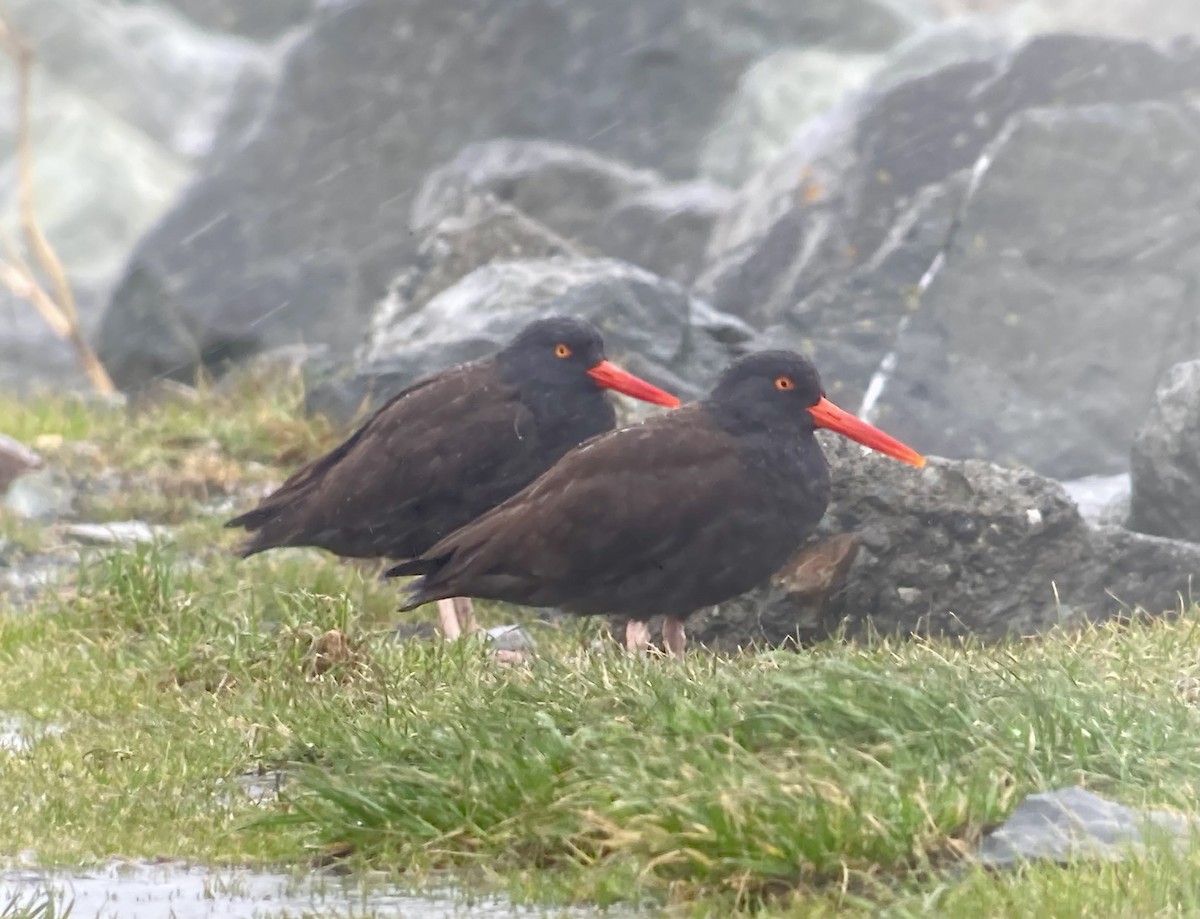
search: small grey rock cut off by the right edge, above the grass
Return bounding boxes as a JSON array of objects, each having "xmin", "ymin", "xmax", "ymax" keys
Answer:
[{"xmin": 1129, "ymin": 362, "xmax": 1200, "ymax": 542}]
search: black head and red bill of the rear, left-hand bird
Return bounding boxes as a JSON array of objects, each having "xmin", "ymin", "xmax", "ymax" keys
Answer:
[{"xmin": 497, "ymin": 316, "xmax": 679, "ymax": 407}]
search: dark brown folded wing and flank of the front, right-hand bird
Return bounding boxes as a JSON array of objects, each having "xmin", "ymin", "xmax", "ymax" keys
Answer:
[{"xmin": 397, "ymin": 404, "xmax": 801, "ymax": 615}]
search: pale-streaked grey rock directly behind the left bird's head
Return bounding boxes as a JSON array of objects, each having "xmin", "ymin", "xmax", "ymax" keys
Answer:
[{"xmin": 308, "ymin": 257, "xmax": 752, "ymax": 427}]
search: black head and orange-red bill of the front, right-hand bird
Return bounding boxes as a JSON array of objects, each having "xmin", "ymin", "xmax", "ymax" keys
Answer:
[{"xmin": 704, "ymin": 352, "xmax": 925, "ymax": 465}]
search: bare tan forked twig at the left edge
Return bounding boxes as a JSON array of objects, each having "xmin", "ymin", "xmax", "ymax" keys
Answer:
[{"xmin": 0, "ymin": 8, "xmax": 116, "ymax": 395}]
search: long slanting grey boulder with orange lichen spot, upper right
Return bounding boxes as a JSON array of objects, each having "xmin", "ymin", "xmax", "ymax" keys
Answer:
[{"xmin": 700, "ymin": 35, "xmax": 1200, "ymax": 320}]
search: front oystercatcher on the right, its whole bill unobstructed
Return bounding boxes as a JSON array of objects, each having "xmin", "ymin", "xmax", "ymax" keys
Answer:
[{"xmin": 388, "ymin": 352, "xmax": 925, "ymax": 654}]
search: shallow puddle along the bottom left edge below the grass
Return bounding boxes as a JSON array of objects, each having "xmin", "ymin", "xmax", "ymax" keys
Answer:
[{"xmin": 0, "ymin": 864, "xmax": 638, "ymax": 919}]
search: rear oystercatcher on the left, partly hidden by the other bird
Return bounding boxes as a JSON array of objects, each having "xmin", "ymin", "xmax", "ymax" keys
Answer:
[{"xmin": 226, "ymin": 317, "xmax": 679, "ymax": 639}]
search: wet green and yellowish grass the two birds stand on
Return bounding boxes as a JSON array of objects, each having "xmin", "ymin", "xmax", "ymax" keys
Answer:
[{"xmin": 0, "ymin": 379, "xmax": 1200, "ymax": 917}]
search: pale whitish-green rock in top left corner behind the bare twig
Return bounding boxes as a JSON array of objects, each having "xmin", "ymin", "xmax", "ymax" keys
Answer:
[{"xmin": 0, "ymin": 0, "xmax": 282, "ymax": 389}]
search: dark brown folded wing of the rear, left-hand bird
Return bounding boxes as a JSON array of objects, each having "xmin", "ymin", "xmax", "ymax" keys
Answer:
[{"xmin": 227, "ymin": 360, "xmax": 541, "ymax": 558}]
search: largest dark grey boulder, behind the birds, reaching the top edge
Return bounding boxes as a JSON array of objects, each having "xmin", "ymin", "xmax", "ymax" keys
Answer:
[{"xmin": 100, "ymin": 0, "xmax": 919, "ymax": 386}]
